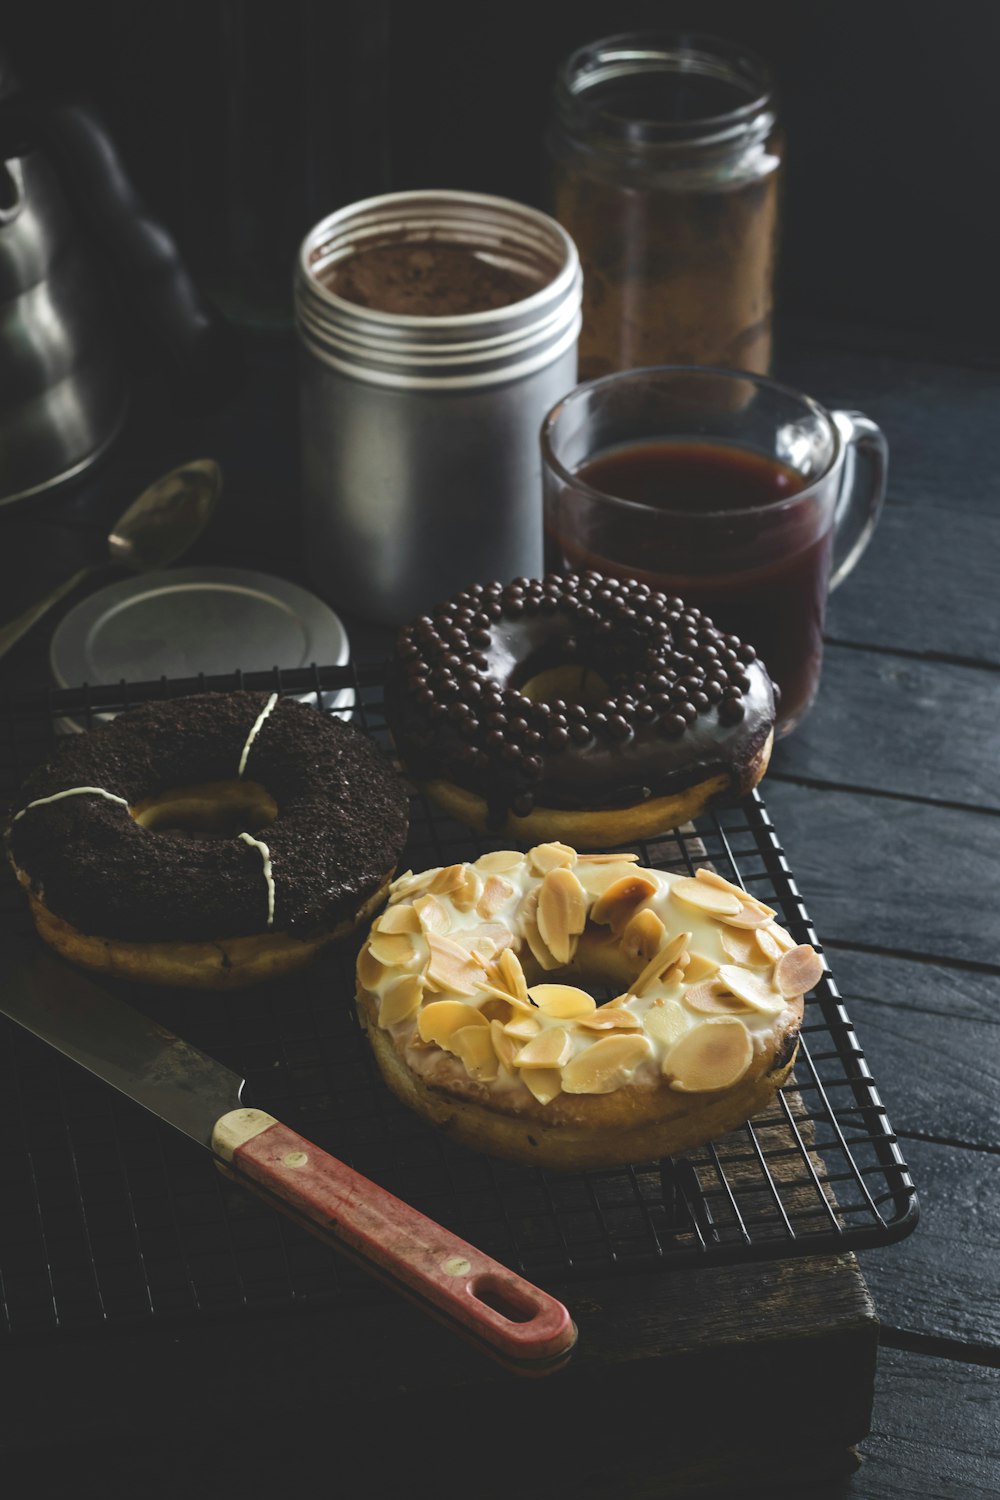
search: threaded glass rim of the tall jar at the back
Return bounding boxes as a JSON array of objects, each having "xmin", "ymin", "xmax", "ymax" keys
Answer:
[{"xmin": 556, "ymin": 32, "xmax": 774, "ymax": 146}]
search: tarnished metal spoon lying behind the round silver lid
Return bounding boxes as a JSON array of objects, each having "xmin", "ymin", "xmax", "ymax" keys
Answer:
[{"xmin": 0, "ymin": 459, "xmax": 222, "ymax": 657}]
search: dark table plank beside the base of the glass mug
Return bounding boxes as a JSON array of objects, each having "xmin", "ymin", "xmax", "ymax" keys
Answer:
[{"xmin": 768, "ymin": 645, "xmax": 1000, "ymax": 812}]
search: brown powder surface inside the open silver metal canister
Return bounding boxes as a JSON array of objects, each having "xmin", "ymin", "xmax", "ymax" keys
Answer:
[{"xmin": 319, "ymin": 240, "xmax": 544, "ymax": 318}]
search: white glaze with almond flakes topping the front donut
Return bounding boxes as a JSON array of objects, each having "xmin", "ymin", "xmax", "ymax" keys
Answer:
[{"xmin": 358, "ymin": 843, "xmax": 823, "ymax": 1106}]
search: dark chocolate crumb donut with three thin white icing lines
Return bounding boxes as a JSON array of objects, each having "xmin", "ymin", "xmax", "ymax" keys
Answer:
[{"xmin": 7, "ymin": 692, "xmax": 408, "ymax": 989}]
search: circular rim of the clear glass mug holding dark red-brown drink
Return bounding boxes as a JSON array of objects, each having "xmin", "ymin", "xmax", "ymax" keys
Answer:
[{"xmin": 540, "ymin": 365, "xmax": 844, "ymax": 524}]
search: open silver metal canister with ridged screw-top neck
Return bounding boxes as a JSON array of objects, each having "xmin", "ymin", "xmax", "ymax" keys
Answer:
[{"xmin": 295, "ymin": 191, "xmax": 582, "ymax": 626}]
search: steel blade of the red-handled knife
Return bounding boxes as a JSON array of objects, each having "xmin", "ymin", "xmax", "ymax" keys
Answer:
[{"xmin": 0, "ymin": 933, "xmax": 244, "ymax": 1148}]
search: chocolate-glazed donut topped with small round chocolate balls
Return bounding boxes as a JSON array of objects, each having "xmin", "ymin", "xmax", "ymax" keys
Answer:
[{"xmin": 387, "ymin": 572, "xmax": 774, "ymax": 848}]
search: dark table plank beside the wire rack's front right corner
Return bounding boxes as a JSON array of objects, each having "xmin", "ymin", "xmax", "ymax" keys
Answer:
[{"xmin": 859, "ymin": 1140, "xmax": 1000, "ymax": 1364}]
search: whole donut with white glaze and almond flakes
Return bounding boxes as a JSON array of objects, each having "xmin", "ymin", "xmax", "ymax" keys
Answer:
[{"xmin": 357, "ymin": 842, "xmax": 823, "ymax": 1170}]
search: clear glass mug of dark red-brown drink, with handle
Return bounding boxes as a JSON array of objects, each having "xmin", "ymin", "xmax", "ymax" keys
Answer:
[{"xmin": 541, "ymin": 366, "xmax": 888, "ymax": 735}]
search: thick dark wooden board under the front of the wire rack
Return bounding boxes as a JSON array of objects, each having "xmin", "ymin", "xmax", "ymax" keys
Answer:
[{"xmin": 0, "ymin": 1256, "xmax": 877, "ymax": 1500}]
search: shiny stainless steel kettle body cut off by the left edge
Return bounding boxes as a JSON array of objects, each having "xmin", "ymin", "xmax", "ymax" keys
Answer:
[{"xmin": 0, "ymin": 152, "xmax": 127, "ymax": 504}]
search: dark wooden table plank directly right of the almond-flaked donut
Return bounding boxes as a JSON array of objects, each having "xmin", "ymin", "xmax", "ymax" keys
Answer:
[{"xmin": 831, "ymin": 951, "xmax": 1000, "ymax": 1151}]
